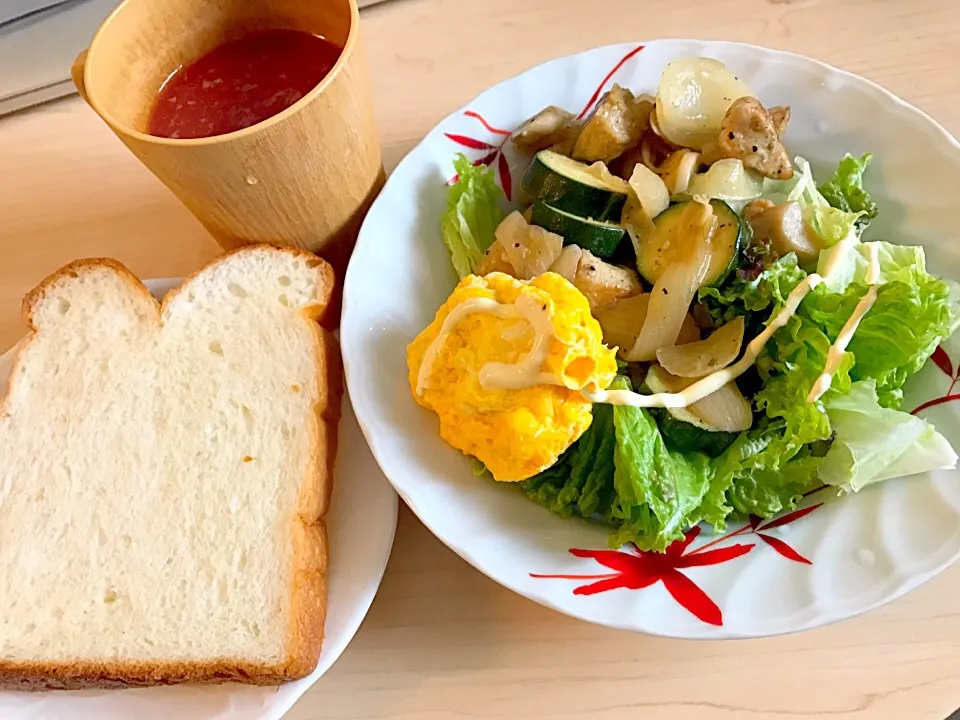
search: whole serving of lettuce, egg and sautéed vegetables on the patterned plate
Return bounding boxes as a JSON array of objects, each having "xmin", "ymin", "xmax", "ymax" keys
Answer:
[{"xmin": 408, "ymin": 58, "xmax": 960, "ymax": 551}]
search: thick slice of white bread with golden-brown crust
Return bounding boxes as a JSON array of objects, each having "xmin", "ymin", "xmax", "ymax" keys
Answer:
[{"xmin": 0, "ymin": 246, "xmax": 341, "ymax": 689}]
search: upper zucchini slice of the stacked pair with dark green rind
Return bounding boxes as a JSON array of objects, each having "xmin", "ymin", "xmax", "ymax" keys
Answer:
[{"xmin": 523, "ymin": 150, "xmax": 630, "ymax": 221}]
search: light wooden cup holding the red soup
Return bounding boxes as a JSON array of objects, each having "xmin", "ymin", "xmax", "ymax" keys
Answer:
[{"xmin": 73, "ymin": 0, "xmax": 384, "ymax": 279}]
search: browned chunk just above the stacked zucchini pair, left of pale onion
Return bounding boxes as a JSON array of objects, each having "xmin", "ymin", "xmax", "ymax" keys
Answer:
[{"xmin": 572, "ymin": 84, "xmax": 653, "ymax": 163}]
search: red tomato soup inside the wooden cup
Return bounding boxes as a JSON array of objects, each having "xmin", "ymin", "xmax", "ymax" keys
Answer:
[{"xmin": 147, "ymin": 30, "xmax": 341, "ymax": 138}]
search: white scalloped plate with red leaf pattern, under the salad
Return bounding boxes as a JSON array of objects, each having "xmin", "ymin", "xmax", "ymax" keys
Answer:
[{"xmin": 342, "ymin": 40, "xmax": 960, "ymax": 638}]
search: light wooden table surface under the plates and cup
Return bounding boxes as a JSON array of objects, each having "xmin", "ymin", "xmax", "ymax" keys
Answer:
[{"xmin": 0, "ymin": 0, "xmax": 960, "ymax": 720}]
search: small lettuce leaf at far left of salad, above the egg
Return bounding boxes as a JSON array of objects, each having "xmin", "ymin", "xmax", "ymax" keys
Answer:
[{"xmin": 440, "ymin": 154, "xmax": 503, "ymax": 277}]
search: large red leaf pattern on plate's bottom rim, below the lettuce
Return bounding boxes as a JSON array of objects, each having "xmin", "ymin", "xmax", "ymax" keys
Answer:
[{"xmin": 530, "ymin": 496, "xmax": 824, "ymax": 626}]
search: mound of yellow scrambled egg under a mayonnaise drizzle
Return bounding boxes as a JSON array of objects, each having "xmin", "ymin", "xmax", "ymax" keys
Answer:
[{"xmin": 407, "ymin": 272, "xmax": 617, "ymax": 481}]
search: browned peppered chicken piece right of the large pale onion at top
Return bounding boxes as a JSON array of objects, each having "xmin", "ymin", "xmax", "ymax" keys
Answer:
[{"xmin": 717, "ymin": 97, "xmax": 793, "ymax": 180}]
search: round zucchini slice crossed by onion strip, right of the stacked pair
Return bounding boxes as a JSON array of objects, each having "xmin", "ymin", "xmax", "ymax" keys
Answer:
[{"xmin": 637, "ymin": 200, "xmax": 748, "ymax": 287}]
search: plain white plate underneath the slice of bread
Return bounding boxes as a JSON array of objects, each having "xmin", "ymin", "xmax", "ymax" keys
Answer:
[{"xmin": 0, "ymin": 279, "xmax": 398, "ymax": 720}]
